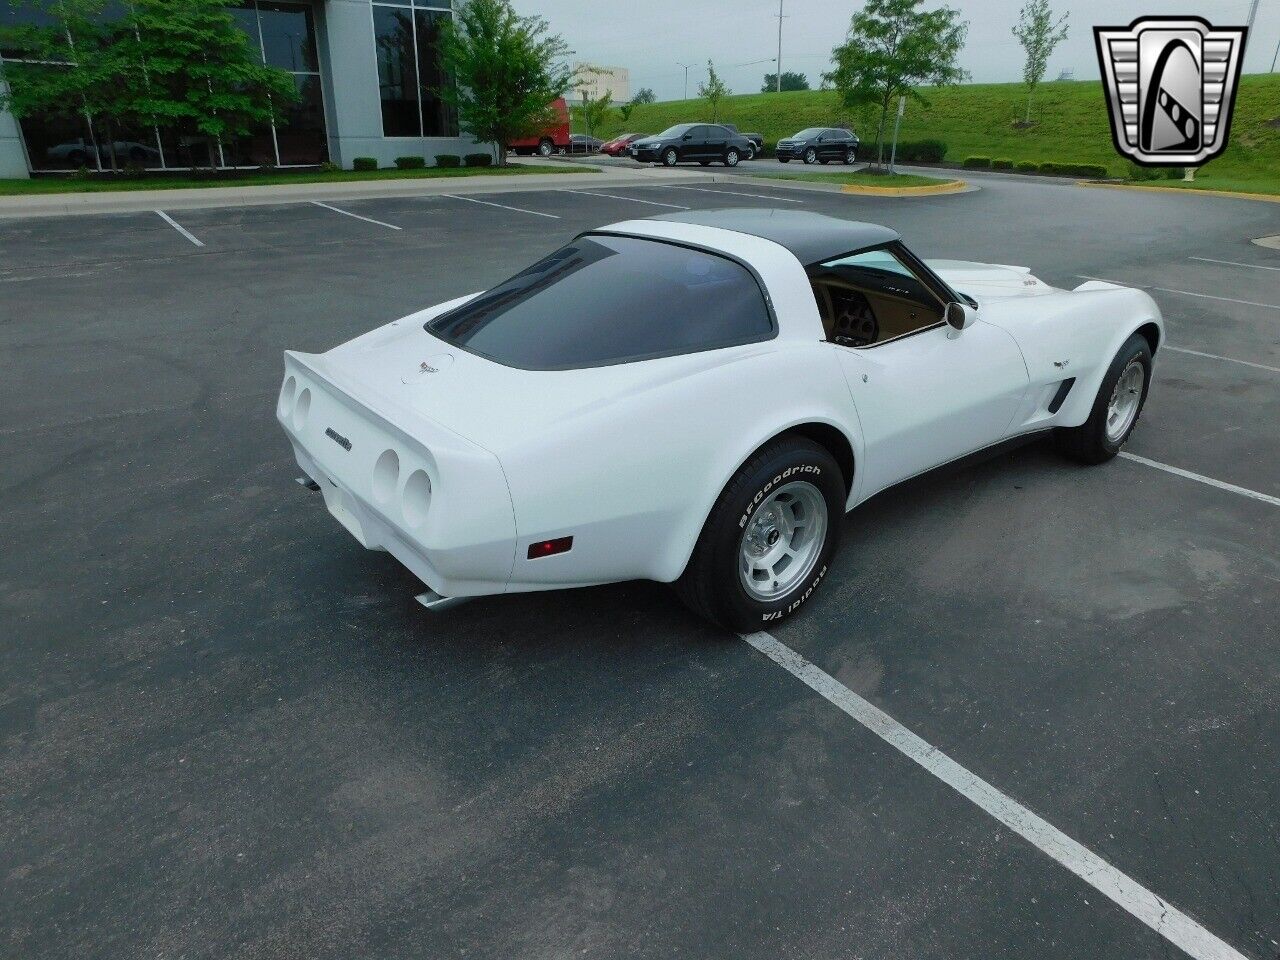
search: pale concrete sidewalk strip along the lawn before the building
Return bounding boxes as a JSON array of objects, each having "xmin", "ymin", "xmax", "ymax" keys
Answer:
[{"xmin": 0, "ymin": 168, "xmax": 723, "ymax": 219}]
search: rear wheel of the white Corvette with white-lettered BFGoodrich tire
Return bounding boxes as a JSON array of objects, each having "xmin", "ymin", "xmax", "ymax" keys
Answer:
[{"xmin": 676, "ymin": 436, "xmax": 845, "ymax": 632}]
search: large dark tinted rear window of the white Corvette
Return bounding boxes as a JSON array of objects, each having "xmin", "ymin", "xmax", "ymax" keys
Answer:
[{"xmin": 426, "ymin": 234, "xmax": 773, "ymax": 370}]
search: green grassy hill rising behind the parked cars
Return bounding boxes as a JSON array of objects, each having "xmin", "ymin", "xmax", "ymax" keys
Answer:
[{"xmin": 586, "ymin": 73, "xmax": 1280, "ymax": 192}]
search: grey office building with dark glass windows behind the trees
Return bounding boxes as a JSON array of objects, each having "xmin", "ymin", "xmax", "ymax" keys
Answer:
[{"xmin": 0, "ymin": 0, "xmax": 471, "ymax": 177}]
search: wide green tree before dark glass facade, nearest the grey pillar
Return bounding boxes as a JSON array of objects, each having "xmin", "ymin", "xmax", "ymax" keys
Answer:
[{"xmin": 119, "ymin": 0, "xmax": 298, "ymax": 166}]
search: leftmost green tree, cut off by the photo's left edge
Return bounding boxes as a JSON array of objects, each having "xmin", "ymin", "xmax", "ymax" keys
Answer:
[{"xmin": 0, "ymin": 0, "xmax": 136, "ymax": 170}]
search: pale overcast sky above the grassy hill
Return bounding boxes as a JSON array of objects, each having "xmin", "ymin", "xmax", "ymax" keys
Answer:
[{"xmin": 513, "ymin": 0, "xmax": 1280, "ymax": 100}]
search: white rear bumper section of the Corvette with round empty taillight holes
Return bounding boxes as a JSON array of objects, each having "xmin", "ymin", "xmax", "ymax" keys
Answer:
[{"xmin": 276, "ymin": 351, "xmax": 516, "ymax": 596}]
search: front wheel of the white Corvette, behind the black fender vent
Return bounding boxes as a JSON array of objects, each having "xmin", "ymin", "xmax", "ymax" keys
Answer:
[{"xmin": 1053, "ymin": 334, "xmax": 1151, "ymax": 463}]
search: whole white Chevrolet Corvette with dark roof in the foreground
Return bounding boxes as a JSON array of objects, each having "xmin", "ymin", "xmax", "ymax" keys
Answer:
[{"xmin": 276, "ymin": 209, "xmax": 1164, "ymax": 630}]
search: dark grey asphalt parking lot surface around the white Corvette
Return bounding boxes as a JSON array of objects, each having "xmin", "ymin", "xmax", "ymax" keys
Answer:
[{"xmin": 0, "ymin": 172, "xmax": 1280, "ymax": 960}]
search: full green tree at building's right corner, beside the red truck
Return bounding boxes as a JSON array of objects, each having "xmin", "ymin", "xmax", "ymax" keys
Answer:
[{"xmin": 440, "ymin": 0, "xmax": 573, "ymax": 166}]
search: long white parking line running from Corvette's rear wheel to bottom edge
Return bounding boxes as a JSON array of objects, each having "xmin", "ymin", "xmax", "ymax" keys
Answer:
[{"xmin": 742, "ymin": 634, "xmax": 1245, "ymax": 960}]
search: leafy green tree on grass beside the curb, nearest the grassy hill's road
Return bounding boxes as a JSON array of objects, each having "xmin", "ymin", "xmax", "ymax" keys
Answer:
[{"xmin": 823, "ymin": 0, "xmax": 969, "ymax": 164}]
